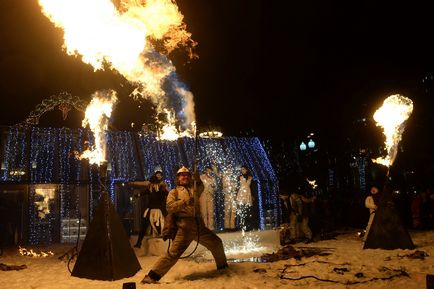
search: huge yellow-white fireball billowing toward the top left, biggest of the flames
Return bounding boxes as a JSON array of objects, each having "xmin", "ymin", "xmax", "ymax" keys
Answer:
[{"xmin": 39, "ymin": 0, "xmax": 197, "ymax": 138}]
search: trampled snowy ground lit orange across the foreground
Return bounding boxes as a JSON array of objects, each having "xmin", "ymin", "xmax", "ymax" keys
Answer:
[{"xmin": 0, "ymin": 230, "xmax": 434, "ymax": 289}]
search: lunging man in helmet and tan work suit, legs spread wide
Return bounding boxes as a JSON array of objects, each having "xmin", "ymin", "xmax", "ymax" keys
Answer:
[{"xmin": 142, "ymin": 167, "xmax": 228, "ymax": 284}]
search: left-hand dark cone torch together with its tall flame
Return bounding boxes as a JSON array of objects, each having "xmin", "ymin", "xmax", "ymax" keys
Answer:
[{"xmin": 71, "ymin": 91, "xmax": 141, "ymax": 280}]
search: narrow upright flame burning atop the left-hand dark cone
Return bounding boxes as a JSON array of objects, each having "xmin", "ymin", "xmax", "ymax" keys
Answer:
[{"xmin": 80, "ymin": 90, "xmax": 117, "ymax": 166}]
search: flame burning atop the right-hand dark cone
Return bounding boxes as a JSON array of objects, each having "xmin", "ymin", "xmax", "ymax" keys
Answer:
[{"xmin": 374, "ymin": 94, "xmax": 413, "ymax": 167}]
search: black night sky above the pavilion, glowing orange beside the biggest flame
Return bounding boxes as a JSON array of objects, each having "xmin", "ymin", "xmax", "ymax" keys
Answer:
[{"xmin": 0, "ymin": 0, "xmax": 434, "ymax": 144}]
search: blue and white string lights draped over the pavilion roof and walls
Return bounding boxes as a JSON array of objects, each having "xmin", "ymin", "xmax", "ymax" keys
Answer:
[{"xmin": 0, "ymin": 126, "xmax": 279, "ymax": 244}]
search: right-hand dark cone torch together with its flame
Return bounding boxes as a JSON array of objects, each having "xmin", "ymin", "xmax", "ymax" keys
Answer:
[{"xmin": 363, "ymin": 94, "xmax": 414, "ymax": 249}]
